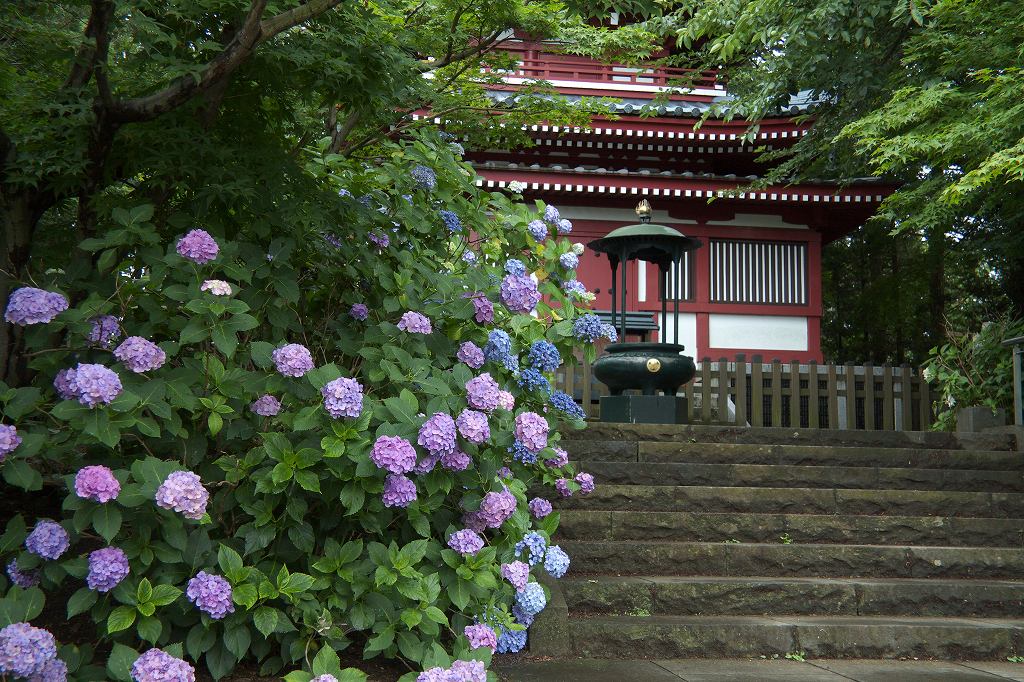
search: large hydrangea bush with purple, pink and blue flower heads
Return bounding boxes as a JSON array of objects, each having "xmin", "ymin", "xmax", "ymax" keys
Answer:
[{"xmin": 0, "ymin": 130, "xmax": 600, "ymax": 682}]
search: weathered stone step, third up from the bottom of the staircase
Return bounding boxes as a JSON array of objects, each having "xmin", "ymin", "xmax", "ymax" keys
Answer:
[{"xmin": 560, "ymin": 540, "xmax": 1024, "ymax": 579}]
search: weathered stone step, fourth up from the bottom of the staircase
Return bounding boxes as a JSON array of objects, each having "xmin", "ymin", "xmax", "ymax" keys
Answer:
[{"xmin": 558, "ymin": 509, "xmax": 1024, "ymax": 547}]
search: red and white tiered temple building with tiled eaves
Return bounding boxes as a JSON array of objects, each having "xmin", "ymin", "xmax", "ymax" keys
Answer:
[{"xmin": 467, "ymin": 33, "xmax": 888, "ymax": 361}]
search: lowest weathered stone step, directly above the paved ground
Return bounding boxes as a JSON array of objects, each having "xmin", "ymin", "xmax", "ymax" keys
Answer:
[{"xmin": 530, "ymin": 615, "xmax": 1024, "ymax": 659}]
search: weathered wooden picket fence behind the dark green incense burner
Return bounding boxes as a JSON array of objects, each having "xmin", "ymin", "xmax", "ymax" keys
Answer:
[{"xmin": 555, "ymin": 355, "xmax": 933, "ymax": 431}]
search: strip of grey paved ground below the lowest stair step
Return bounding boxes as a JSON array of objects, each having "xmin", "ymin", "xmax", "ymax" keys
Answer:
[{"xmin": 498, "ymin": 658, "xmax": 1024, "ymax": 682}]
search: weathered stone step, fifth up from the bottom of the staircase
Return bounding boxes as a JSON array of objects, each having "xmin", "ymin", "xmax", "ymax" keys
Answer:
[{"xmin": 559, "ymin": 485, "xmax": 1024, "ymax": 518}]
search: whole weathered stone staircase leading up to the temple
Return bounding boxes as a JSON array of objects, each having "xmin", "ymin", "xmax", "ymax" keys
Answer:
[{"xmin": 529, "ymin": 424, "xmax": 1024, "ymax": 659}]
